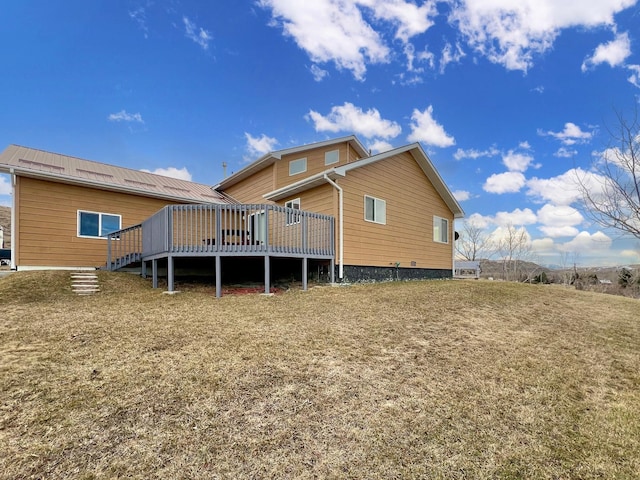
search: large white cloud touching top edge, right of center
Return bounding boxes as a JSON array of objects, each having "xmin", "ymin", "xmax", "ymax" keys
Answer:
[{"xmin": 450, "ymin": 0, "xmax": 637, "ymax": 71}]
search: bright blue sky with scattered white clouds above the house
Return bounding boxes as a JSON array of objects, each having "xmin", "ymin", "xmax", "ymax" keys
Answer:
[{"xmin": 0, "ymin": 0, "xmax": 640, "ymax": 265}]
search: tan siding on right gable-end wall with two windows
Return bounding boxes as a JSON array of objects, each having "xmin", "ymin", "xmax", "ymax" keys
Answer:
[{"xmin": 339, "ymin": 153, "xmax": 453, "ymax": 269}]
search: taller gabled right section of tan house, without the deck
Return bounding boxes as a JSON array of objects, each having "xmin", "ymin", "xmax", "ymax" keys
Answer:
[{"xmin": 216, "ymin": 136, "xmax": 464, "ymax": 281}]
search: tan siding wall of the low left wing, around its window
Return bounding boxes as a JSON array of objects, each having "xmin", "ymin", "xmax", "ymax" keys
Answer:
[{"xmin": 16, "ymin": 177, "xmax": 182, "ymax": 267}]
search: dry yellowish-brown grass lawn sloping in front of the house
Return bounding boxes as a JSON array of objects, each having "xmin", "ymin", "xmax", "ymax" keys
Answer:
[{"xmin": 0, "ymin": 272, "xmax": 640, "ymax": 479}]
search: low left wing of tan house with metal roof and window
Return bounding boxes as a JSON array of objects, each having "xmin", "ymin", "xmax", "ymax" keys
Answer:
[{"xmin": 0, "ymin": 145, "xmax": 226, "ymax": 270}]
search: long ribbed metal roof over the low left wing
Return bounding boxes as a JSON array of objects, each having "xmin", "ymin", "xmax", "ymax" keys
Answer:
[{"xmin": 0, "ymin": 145, "xmax": 230, "ymax": 203}]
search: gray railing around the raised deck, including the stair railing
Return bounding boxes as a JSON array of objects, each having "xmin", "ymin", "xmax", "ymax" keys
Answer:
[{"xmin": 107, "ymin": 204, "xmax": 335, "ymax": 269}]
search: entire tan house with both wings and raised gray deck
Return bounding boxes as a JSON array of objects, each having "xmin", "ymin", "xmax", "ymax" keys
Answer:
[{"xmin": 0, "ymin": 136, "xmax": 463, "ymax": 294}]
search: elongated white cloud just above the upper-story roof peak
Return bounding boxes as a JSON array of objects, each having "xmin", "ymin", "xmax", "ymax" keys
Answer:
[{"xmin": 307, "ymin": 102, "xmax": 402, "ymax": 139}]
